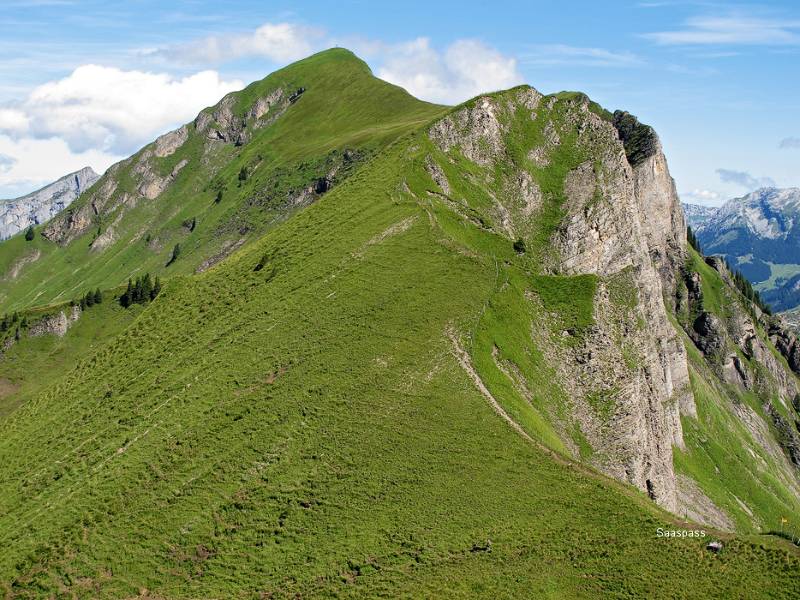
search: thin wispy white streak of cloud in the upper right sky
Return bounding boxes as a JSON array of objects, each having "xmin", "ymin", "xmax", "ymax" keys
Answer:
[{"xmin": 642, "ymin": 15, "xmax": 800, "ymax": 46}]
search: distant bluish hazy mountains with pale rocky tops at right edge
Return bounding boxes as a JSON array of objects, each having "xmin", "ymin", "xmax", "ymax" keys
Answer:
[{"xmin": 684, "ymin": 188, "xmax": 800, "ymax": 311}]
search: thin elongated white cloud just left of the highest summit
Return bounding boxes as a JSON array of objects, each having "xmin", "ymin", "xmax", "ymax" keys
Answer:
[{"xmin": 145, "ymin": 23, "xmax": 324, "ymax": 64}]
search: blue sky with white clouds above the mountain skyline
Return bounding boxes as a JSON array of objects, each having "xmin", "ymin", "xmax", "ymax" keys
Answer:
[{"xmin": 0, "ymin": 0, "xmax": 800, "ymax": 204}]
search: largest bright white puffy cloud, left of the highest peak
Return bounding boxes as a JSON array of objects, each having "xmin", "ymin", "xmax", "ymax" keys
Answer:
[{"xmin": 0, "ymin": 65, "xmax": 243, "ymax": 154}]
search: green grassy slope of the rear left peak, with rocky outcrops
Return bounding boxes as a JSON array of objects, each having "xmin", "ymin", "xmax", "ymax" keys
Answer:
[{"xmin": 0, "ymin": 49, "xmax": 442, "ymax": 311}]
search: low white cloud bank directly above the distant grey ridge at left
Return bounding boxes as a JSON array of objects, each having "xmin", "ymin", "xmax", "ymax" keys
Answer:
[{"xmin": 0, "ymin": 135, "xmax": 123, "ymax": 198}]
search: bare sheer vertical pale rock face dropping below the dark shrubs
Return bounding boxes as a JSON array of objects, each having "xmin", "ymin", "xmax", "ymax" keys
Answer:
[{"xmin": 555, "ymin": 103, "xmax": 695, "ymax": 510}]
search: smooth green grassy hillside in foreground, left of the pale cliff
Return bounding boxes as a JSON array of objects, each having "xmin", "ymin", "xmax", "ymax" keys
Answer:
[{"xmin": 0, "ymin": 51, "xmax": 800, "ymax": 598}]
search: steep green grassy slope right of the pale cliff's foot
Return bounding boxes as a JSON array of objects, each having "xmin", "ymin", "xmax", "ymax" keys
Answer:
[{"xmin": 675, "ymin": 248, "xmax": 800, "ymax": 530}]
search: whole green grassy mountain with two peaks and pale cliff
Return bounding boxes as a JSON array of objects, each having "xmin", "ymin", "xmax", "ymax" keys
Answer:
[{"xmin": 0, "ymin": 49, "xmax": 800, "ymax": 598}]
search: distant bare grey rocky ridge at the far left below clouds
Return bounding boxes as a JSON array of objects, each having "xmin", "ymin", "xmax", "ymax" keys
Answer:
[{"xmin": 0, "ymin": 167, "xmax": 99, "ymax": 239}]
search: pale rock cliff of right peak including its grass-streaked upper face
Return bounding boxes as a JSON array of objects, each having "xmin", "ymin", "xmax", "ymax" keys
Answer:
[{"xmin": 428, "ymin": 88, "xmax": 694, "ymax": 510}]
